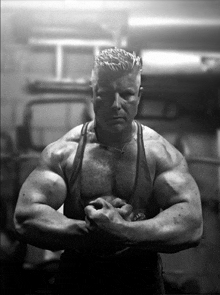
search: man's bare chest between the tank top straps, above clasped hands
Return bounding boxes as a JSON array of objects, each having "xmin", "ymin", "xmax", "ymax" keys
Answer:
[{"xmin": 81, "ymin": 144, "xmax": 137, "ymax": 206}]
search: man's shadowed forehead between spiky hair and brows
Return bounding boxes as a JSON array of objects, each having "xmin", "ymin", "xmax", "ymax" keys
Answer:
[{"xmin": 97, "ymin": 72, "xmax": 141, "ymax": 90}]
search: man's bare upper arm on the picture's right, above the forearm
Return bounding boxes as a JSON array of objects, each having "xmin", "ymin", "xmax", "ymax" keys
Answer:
[{"xmin": 150, "ymin": 138, "xmax": 200, "ymax": 210}]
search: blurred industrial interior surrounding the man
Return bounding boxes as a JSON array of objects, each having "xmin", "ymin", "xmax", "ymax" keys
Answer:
[{"xmin": 0, "ymin": 0, "xmax": 220, "ymax": 295}]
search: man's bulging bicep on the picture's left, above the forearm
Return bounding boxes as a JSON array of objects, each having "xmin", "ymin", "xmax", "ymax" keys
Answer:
[{"xmin": 18, "ymin": 167, "xmax": 66, "ymax": 210}]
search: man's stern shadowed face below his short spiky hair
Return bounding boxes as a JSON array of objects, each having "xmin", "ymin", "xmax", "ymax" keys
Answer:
[{"xmin": 93, "ymin": 72, "xmax": 141, "ymax": 132}]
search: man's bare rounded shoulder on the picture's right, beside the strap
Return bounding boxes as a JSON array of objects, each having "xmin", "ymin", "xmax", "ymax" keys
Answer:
[{"xmin": 142, "ymin": 125, "xmax": 188, "ymax": 173}]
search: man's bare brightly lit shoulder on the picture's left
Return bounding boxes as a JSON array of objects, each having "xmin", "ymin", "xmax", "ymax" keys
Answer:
[{"xmin": 39, "ymin": 125, "xmax": 83, "ymax": 169}]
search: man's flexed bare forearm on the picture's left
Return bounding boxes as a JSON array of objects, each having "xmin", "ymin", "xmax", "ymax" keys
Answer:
[{"xmin": 14, "ymin": 204, "xmax": 88, "ymax": 250}]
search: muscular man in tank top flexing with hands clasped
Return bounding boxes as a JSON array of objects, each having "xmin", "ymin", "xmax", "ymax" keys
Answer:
[{"xmin": 15, "ymin": 48, "xmax": 202, "ymax": 295}]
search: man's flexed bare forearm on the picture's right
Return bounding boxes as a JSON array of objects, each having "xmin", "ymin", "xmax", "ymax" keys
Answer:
[{"xmin": 120, "ymin": 204, "xmax": 202, "ymax": 253}]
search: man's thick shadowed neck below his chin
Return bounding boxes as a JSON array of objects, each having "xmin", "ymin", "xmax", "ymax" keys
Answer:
[{"xmin": 94, "ymin": 121, "xmax": 136, "ymax": 148}]
